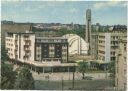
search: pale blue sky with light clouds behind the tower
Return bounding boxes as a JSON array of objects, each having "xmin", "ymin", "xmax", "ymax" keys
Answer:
[{"xmin": 1, "ymin": 0, "xmax": 127, "ymax": 25}]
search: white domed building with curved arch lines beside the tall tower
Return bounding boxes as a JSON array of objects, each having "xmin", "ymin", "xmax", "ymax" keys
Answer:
[{"xmin": 63, "ymin": 34, "xmax": 88, "ymax": 55}]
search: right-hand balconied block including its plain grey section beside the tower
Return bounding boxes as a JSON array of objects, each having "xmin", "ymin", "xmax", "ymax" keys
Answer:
[{"xmin": 92, "ymin": 25, "xmax": 127, "ymax": 62}]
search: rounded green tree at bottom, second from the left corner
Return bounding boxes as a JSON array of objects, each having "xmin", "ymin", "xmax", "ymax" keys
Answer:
[{"xmin": 15, "ymin": 67, "xmax": 35, "ymax": 90}]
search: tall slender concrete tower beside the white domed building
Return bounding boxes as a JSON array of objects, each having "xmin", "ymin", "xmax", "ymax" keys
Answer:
[{"xmin": 85, "ymin": 9, "xmax": 91, "ymax": 55}]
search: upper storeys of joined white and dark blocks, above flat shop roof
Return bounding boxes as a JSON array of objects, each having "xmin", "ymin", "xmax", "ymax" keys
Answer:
[{"xmin": 6, "ymin": 32, "xmax": 68, "ymax": 63}]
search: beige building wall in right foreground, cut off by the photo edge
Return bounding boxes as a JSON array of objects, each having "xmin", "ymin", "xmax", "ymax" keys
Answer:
[{"xmin": 115, "ymin": 38, "xmax": 127, "ymax": 91}]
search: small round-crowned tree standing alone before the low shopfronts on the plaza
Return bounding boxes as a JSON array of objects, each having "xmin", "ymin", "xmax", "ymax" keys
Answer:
[{"xmin": 78, "ymin": 61, "xmax": 89, "ymax": 79}]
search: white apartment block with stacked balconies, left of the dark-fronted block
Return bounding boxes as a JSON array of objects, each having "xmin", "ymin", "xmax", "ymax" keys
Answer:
[{"xmin": 6, "ymin": 32, "xmax": 35, "ymax": 61}]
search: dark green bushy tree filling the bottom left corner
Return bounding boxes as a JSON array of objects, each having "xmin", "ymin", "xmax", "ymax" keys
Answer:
[{"xmin": 1, "ymin": 63, "xmax": 17, "ymax": 89}]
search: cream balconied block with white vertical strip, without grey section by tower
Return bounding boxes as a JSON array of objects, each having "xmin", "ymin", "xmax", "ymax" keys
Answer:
[{"xmin": 97, "ymin": 26, "xmax": 127, "ymax": 62}]
